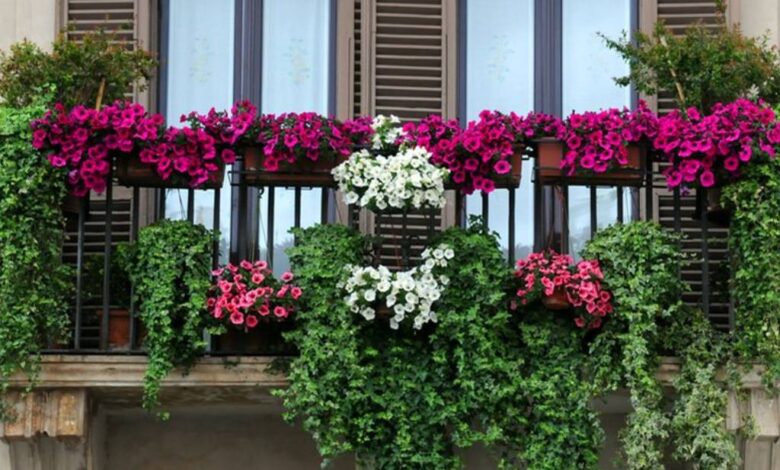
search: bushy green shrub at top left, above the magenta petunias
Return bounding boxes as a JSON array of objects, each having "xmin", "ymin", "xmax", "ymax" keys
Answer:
[{"xmin": 0, "ymin": 30, "xmax": 157, "ymax": 107}]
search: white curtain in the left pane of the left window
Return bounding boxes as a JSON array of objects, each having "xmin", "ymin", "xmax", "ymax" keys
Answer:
[{"xmin": 163, "ymin": 0, "xmax": 235, "ymax": 262}]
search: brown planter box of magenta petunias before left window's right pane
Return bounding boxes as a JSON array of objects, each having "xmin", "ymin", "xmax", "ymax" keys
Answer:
[{"xmin": 243, "ymin": 147, "xmax": 345, "ymax": 188}]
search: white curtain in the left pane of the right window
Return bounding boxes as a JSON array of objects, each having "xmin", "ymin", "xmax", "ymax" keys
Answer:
[{"xmin": 466, "ymin": 0, "xmax": 534, "ymax": 258}]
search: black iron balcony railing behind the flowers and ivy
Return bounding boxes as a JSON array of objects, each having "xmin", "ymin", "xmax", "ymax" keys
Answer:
[{"xmin": 50, "ymin": 156, "xmax": 733, "ymax": 355}]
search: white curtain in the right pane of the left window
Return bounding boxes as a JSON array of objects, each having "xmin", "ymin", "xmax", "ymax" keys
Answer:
[{"xmin": 258, "ymin": 0, "xmax": 331, "ymax": 274}]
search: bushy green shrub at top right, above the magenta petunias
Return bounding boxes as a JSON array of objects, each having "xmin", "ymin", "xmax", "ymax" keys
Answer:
[{"xmin": 602, "ymin": 0, "xmax": 780, "ymax": 111}]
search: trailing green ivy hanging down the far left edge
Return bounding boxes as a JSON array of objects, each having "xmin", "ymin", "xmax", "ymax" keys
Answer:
[{"xmin": 0, "ymin": 102, "xmax": 72, "ymax": 419}]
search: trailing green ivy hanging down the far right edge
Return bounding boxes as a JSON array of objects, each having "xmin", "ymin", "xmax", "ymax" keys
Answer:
[{"xmin": 723, "ymin": 158, "xmax": 780, "ymax": 387}]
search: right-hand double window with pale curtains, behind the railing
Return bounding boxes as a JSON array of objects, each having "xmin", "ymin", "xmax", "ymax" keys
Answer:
[{"xmin": 460, "ymin": 0, "xmax": 636, "ymax": 260}]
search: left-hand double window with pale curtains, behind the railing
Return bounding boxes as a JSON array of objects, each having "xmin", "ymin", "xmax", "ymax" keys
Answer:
[{"xmin": 161, "ymin": 0, "xmax": 332, "ymax": 273}]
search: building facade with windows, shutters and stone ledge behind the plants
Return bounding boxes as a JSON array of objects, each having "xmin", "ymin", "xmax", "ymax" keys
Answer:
[{"xmin": 0, "ymin": 0, "xmax": 780, "ymax": 470}]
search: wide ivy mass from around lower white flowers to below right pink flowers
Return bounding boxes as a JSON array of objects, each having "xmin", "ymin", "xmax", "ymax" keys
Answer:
[{"xmin": 276, "ymin": 221, "xmax": 601, "ymax": 469}]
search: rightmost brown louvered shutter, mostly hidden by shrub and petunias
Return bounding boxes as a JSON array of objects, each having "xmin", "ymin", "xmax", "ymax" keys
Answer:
[{"xmin": 642, "ymin": 0, "xmax": 730, "ymax": 330}]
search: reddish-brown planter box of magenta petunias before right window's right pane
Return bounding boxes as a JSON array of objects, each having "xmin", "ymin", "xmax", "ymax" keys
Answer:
[{"xmin": 534, "ymin": 138, "xmax": 647, "ymax": 186}]
